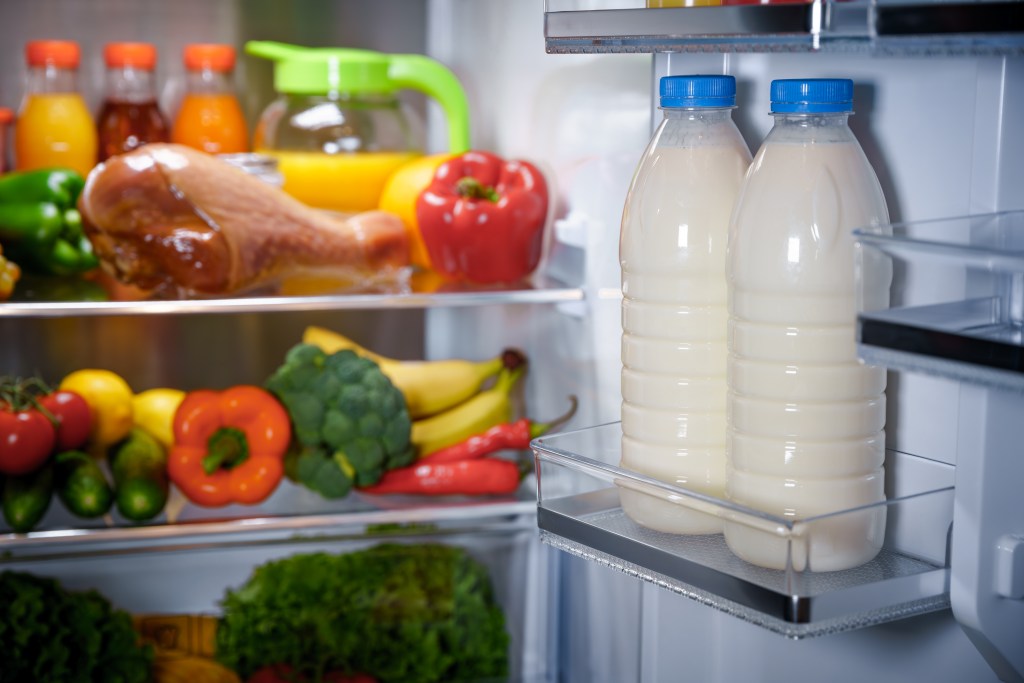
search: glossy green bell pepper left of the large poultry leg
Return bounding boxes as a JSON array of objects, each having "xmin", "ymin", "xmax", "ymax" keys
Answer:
[{"xmin": 0, "ymin": 168, "xmax": 99, "ymax": 275}]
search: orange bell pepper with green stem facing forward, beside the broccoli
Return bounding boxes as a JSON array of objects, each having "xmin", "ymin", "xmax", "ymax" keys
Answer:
[{"xmin": 167, "ymin": 385, "xmax": 292, "ymax": 507}]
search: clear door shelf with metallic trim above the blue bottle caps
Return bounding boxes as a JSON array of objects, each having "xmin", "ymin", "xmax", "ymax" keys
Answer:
[{"xmin": 544, "ymin": 0, "xmax": 1024, "ymax": 54}]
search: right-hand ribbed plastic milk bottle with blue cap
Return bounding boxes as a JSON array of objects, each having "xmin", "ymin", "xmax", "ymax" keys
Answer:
[{"xmin": 725, "ymin": 79, "xmax": 891, "ymax": 571}]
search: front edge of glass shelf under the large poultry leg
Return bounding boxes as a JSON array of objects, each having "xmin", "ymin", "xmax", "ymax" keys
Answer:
[{"xmin": 0, "ymin": 276, "xmax": 583, "ymax": 317}]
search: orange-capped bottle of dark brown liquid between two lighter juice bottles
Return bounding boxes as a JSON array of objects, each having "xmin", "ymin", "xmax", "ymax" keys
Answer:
[{"xmin": 96, "ymin": 43, "xmax": 170, "ymax": 161}]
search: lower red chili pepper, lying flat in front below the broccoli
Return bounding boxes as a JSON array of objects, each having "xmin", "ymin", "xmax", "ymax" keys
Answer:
[{"xmin": 359, "ymin": 458, "xmax": 524, "ymax": 496}]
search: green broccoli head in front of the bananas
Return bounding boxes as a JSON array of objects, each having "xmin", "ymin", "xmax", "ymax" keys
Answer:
[{"xmin": 266, "ymin": 344, "xmax": 415, "ymax": 498}]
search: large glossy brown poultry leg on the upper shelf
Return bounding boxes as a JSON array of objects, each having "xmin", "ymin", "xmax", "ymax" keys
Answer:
[{"xmin": 79, "ymin": 144, "xmax": 409, "ymax": 297}]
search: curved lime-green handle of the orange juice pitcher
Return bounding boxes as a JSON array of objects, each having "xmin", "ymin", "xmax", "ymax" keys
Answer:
[{"xmin": 388, "ymin": 54, "xmax": 469, "ymax": 154}]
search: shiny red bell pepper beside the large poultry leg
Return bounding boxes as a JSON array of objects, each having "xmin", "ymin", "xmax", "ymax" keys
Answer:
[{"xmin": 416, "ymin": 152, "xmax": 548, "ymax": 284}]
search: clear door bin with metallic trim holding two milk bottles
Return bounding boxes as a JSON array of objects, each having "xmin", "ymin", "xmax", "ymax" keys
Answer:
[{"xmin": 532, "ymin": 423, "xmax": 953, "ymax": 638}]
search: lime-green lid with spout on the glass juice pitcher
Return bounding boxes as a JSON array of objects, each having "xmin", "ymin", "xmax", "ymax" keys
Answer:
[{"xmin": 246, "ymin": 40, "xmax": 397, "ymax": 95}]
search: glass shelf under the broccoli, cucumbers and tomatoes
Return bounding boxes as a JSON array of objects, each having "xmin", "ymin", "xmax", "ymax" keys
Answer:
[{"xmin": 0, "ymin": 481, "xmax": 537, "ymax": 569}]
